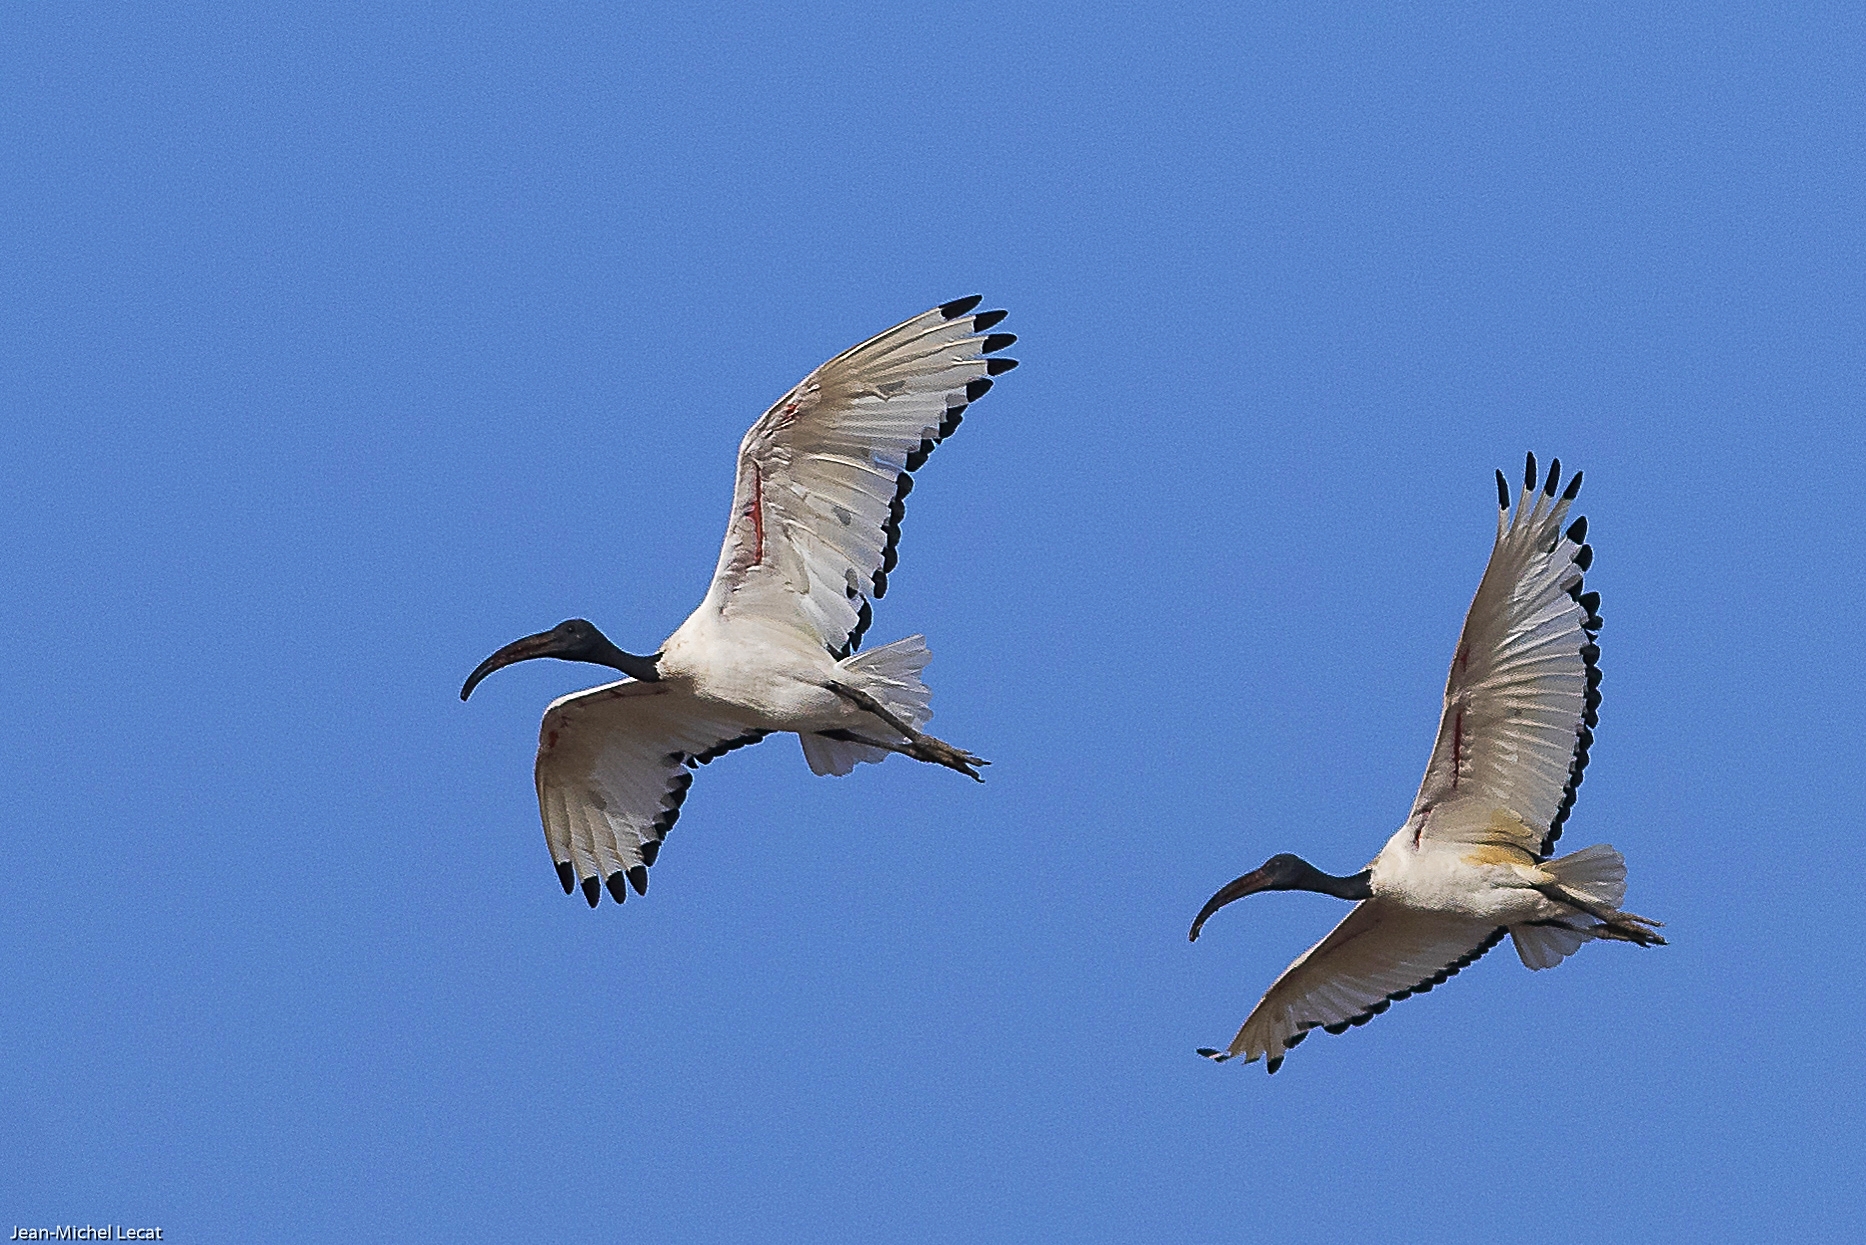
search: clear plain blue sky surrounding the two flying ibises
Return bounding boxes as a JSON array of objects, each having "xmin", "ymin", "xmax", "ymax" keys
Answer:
[{"xmin": 0, "ymin": 2, "xmax": 1866, "ymax": 1241}]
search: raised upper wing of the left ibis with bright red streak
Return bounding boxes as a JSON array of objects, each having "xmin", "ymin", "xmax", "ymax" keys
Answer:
[{"xmin": 707, "ymin": 297, "xmax": 1017, "ymax": 659}]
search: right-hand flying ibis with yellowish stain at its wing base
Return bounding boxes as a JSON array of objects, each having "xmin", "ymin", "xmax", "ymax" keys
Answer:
[{"xmin": 1191, "ymin": 454, "xmax": 1664, "ymax": 1071}]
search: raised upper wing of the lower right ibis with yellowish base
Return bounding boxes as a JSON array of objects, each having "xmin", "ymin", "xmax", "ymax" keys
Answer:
[{"xmin": 1407, "ymin": 455, "xmax": 1601, "ymax": 859}]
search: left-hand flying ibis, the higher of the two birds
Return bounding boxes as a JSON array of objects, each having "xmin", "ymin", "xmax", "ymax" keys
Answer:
[{"xmin": 461, "ymin": 297, "xmax": 1017, "ymax": 907}]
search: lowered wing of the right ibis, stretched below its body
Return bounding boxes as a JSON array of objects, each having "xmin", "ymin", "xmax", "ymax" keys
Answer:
[{"xmin": 1200, "ymin": 898, "xmax": 1506, "ymax": 1071}]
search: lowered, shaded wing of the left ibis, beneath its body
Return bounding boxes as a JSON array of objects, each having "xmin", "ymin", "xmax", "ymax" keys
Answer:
[{"xmin": 536, "ymin": 679, "xmax": 765, "ymax": 907}]
